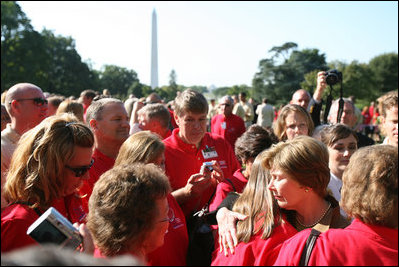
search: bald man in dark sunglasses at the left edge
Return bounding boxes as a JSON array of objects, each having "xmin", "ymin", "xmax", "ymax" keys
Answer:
[{"xmin": 1, "ymin": 83, "xmax": 48, "ymax": 188}]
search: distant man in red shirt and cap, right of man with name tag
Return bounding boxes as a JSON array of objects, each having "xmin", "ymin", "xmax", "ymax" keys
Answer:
[{"xmin": 211, "ymin": 95, "xmax": 245, "ymax": 149}]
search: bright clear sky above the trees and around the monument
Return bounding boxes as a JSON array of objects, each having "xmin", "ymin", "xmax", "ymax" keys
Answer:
[{"xmin": 18, "ymin": 1, "xmax": 398, "ymax": 87}]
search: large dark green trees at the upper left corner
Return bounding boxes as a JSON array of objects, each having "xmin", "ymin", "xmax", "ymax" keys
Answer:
[{"xmin": 1, "ymin": 1, "xmax": 98, "ymax": 96}]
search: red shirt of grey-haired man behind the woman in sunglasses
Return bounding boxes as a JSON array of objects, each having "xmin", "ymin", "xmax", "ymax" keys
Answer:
[{"xmin": 79, "ymin": 148, "xmax": 115, "ymax": 213}]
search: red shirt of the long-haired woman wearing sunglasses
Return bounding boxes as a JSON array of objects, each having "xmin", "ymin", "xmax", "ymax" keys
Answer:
[{"xmin": 1, "ymin": 198, "xmax": 86, "ymax": 252}]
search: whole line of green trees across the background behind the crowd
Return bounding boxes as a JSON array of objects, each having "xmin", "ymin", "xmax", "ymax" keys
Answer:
[{"xmin": 1, "ymin": 1, "xmax": 398, "ymax": 104}]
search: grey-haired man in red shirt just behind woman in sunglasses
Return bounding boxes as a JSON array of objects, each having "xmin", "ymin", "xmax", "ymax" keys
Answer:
[{"xmin": 80, "ymin": 98, "xmax": 130, "ymax": 211}]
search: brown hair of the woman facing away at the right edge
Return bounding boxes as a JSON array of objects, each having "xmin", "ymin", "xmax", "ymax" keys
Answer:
[{"xmin": 340, "ymin": 145, "xmax": 398, "ymax": 228}]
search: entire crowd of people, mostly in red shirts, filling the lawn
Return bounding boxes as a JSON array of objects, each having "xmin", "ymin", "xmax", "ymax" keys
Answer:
[{"xmin": 1, "ymin": 72, "xmax": 398, "ymax": 266}]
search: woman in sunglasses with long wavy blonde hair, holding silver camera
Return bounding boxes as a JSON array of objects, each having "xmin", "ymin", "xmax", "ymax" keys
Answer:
[{"xmin": 1, "ymin": 114, "xmax": 94, "ymax": 252}]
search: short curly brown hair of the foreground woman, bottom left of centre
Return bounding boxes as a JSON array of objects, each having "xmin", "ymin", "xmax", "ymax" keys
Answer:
[{"xmin": 87, "ymin": 163, "xmax": 171, "ymax": 256}]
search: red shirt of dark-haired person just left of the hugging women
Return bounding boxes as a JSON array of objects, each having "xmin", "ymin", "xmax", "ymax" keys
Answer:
[{"xmin": 209, "ymin": 169, "xmax": 248, "ymax": 214}]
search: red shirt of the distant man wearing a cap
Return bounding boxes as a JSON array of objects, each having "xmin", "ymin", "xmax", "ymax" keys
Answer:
[{"xmin": 211, "ymin": 114, "xmax": 245, "ymax": 149}]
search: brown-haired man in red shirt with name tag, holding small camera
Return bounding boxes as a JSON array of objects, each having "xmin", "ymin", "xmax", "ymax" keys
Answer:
[{"xmin": 164, "ymin": 89, "xmax": 240, "ymax": 219}]
